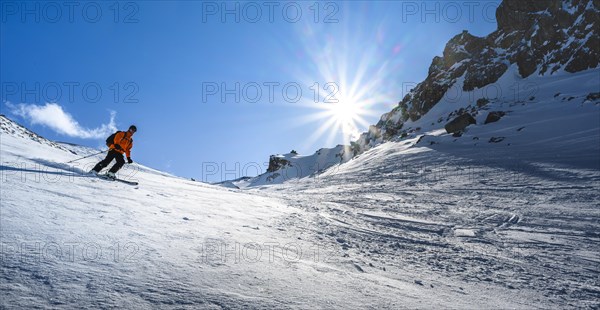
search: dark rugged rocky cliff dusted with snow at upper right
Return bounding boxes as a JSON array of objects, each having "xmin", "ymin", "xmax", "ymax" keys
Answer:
[{"xmin": 352, "ymin": 0, "xmax": 600, "ymax": 153}]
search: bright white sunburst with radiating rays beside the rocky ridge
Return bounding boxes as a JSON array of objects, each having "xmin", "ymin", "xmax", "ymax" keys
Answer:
[{"xmin": 290, "ymin": 13, "xmax": 399, "ymax": 148}]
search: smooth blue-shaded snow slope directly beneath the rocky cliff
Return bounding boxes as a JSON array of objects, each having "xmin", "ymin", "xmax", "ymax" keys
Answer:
[{"xmin": 384, "ymin": 66, "xmax": 600, "ymax": 160}]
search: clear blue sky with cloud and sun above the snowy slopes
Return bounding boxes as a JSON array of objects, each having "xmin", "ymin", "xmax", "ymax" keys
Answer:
[{"xmin": 0, "ymin": 1, "xmax": 498, "ymax": 181}]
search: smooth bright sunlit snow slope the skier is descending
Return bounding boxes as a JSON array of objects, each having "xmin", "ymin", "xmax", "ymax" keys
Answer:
[{"xmin": 0, "ymin": 118, "xmax": 523, "ymax": 309}]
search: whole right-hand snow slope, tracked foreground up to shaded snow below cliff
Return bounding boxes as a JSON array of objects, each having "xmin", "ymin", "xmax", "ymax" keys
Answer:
[{"xmin": 250, "ymin": 92, "xmax": 600, "ymax": 309}]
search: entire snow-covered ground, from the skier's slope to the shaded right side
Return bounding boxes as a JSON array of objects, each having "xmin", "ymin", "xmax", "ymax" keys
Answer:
[{"xmin": 0, "ymin": 70, "xmax": 600, "ymax": 309}]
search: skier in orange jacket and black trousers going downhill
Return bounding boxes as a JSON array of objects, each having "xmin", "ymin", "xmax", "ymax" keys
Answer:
[{"xmin": 90, "ymin": 125, "xmax": 137, "ymax": 179}]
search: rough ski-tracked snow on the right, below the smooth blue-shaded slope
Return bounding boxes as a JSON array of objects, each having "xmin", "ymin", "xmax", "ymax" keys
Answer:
[{"xmin": 257, "ymin": 143, "xmax": 600, "ymax": 308}]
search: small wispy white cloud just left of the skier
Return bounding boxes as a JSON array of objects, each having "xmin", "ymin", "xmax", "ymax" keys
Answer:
[{"xmin": 6, "ymin": 102, "xmax": 117, "ymax": 139}]
